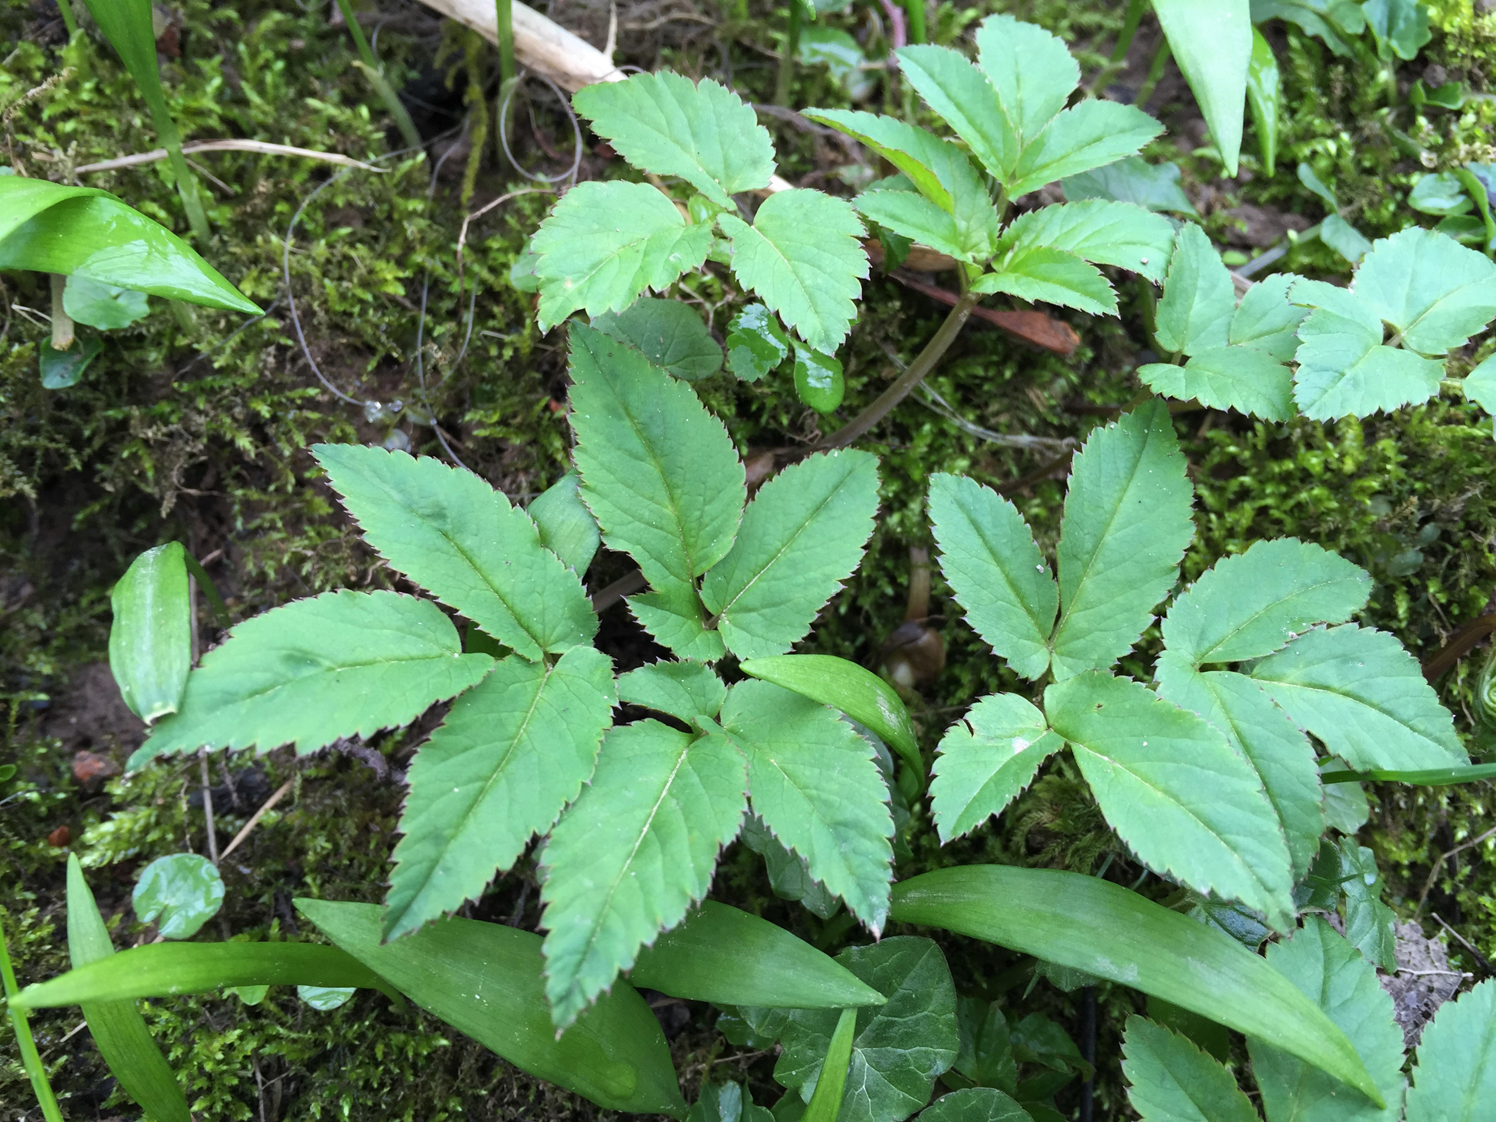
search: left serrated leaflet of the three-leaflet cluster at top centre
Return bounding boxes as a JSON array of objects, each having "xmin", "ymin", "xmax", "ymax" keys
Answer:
[{"xmin": 530, "ymin": 180, "xmax": 712, "ymax": 331}]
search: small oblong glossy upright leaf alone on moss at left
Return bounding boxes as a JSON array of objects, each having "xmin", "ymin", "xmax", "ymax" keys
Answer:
[{"xmin": 109, "ymin": 542, "xmax": 191, "ymax": 724}]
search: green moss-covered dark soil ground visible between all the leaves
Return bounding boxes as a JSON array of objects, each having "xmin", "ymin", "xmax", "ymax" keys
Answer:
[{"xmin": 0, "ymin": 0, "xmax": 1496, "ymax": 1122}]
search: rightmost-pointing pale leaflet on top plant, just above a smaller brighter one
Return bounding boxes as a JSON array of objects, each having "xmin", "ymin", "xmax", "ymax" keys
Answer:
[{"xmin": 998, "ymin": 199, "xmax": 1174, "ymax": 281}]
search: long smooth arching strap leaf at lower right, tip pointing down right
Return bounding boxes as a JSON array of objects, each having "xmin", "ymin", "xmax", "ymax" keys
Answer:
[{"xmin": 892, "ymin": 865, "xmax": 1376, "ymax": 1107}]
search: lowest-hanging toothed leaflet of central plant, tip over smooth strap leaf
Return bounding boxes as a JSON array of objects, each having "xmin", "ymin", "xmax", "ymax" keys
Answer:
[{"xmin": 540, "ymin": 721, "xmax": 748, "ymax": 1029}]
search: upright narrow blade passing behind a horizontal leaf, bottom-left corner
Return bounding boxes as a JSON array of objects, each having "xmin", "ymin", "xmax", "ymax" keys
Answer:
[{"xmin": 67, "ymin": 853, "xmax": 191, "ymax": 1122}]
